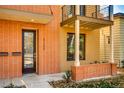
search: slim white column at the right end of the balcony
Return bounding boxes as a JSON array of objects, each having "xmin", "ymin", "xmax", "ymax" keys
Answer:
[{"xmin": 109, "ymin": 5, "xmax": 114, "ymax": 63}]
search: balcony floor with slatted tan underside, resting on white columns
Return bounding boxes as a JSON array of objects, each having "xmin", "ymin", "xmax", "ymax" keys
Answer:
[{"xmin": 61, "ymin": 16, "xmax": 113, "ymax": 30}]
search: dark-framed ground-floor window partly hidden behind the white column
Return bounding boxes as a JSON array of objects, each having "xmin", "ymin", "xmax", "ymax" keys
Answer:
[{"xmin": 67, "ymin": 33, "xmax": 85, "ymax": 61}]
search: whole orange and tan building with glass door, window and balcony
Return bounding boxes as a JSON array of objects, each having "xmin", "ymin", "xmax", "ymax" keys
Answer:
[{"xmin": 0, "ymin": 5, "xmax": 113, "ymax": 78}]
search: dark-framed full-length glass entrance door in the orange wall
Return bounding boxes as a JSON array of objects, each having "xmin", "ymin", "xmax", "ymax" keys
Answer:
[{"xmin": 22, "ymin": 29, "xmax": 36, "ymax": 73}]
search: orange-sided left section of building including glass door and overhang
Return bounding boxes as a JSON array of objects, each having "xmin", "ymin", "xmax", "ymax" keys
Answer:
[{"xmin": 0, "ymin": 5, "xmax": 61, "ymax": 79}]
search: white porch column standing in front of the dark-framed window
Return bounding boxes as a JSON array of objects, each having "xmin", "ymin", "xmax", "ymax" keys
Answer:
[{"xmin": 74, "ymin": 5, "xmax": 80, "ymax": 66}]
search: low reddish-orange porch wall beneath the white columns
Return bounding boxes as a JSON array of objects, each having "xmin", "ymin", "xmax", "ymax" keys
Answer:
[{"xmin": 72, "ymin": 63, "xmax": 117, "ymax": 81}]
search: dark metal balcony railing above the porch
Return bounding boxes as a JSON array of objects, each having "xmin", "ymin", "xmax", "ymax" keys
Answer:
[{"xmin": 62, "ymin": 5, "xmax": 111, "ymax": 21}]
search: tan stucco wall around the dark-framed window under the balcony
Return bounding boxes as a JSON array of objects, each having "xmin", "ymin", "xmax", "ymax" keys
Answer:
[{"xmin": 60, "ymin": 28, "xmax": 99, "ymax": 71}]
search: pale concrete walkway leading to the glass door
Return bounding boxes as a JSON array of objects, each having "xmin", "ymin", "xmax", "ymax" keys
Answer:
[{"xmin": 0, "ymin": 73, "xmax": 64, "ymax": 88}]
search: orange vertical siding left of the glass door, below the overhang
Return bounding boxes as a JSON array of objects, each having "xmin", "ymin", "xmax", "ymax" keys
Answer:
[{"xmin": 0, "ymin": 21, "xmax": 22, "ymax": 78}]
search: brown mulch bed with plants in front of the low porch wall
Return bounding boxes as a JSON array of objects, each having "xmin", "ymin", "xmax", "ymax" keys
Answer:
[{"xmin": 49, "ymin": 75, "xmax": 124, "ymax": 88}]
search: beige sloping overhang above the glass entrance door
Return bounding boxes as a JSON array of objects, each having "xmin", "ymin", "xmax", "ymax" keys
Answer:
[{"xmin": 0, "ymin": 8, "xmax": 53, "ymax": 24}]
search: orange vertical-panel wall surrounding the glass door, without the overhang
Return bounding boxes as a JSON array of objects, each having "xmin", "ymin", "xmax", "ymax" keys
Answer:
[{"xmin": 0, "ymin": 6, "xmax": 60, "ymax": 78}]
